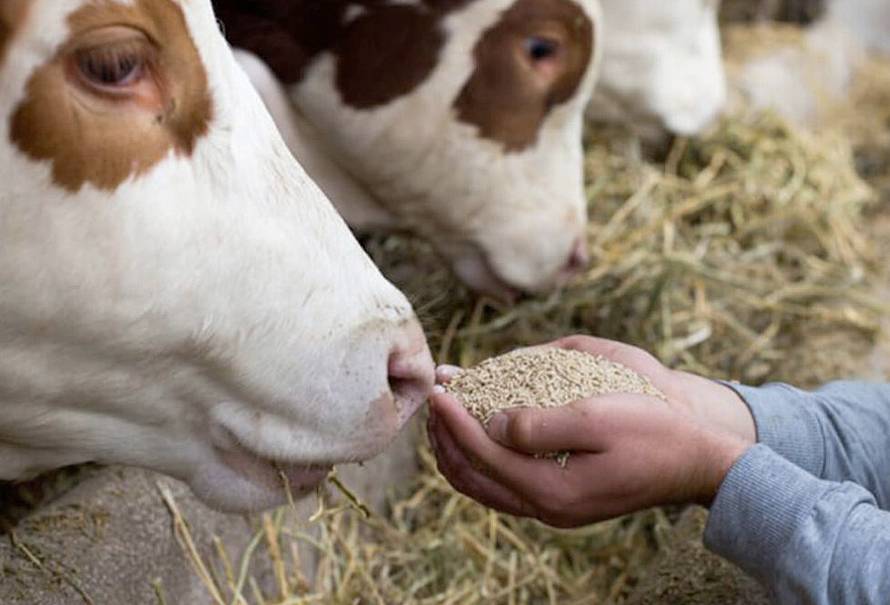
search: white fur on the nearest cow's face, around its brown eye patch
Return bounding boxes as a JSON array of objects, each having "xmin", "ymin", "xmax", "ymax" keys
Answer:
[{"xmin": 0, "ymin": 0, "xmax": 431, "ymax": 509}]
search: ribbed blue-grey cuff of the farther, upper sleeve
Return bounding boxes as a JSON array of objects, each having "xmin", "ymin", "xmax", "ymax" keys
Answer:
[{"xmin": 723, "ymin": 382, "xmax": 825, "ymax": 477}]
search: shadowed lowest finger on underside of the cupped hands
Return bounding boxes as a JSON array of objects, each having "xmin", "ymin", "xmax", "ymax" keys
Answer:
[{"xmin": 434, "ymin": 412, "xmax": 534, "ymax": 517}]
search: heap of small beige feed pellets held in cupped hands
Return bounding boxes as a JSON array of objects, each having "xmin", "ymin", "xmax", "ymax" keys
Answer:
[{"xmin": 446, "ymin": 347, "xmax": 667, "ymax": 466}]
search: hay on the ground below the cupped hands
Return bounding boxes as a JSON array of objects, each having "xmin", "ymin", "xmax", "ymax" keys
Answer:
[{"xmin": 161, "ymin": 446, "xmax": 672, "ymax": 605}]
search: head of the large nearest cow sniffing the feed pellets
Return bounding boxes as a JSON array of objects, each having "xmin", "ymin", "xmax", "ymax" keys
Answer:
[{"xmin": 0, "ymin": 0, "xmax": 432, "ymax": 510}]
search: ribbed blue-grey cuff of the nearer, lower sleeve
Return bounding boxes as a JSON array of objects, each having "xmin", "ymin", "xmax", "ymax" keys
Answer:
[{"xmin": 704, "ymin": 445, "xmax": 831, "ymax": 580}]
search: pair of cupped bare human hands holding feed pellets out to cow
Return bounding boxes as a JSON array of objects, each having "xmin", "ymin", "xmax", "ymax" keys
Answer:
[{"xmin": 429, "ymin": 337, "xmax": 755, "ymax": 527}]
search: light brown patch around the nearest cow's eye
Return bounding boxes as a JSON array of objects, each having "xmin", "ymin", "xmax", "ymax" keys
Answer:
[{"xmin": 10, "ymin": 0, "xmax": 212, "ymax": 191}]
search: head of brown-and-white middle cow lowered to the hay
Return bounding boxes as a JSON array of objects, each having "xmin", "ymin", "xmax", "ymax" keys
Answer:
[{"xmin": 214, "ymin": 0, "xmax": 599, "ymax": 296}]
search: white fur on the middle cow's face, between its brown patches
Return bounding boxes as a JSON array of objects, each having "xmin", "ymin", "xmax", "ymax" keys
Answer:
[{"xmin": 246, "ymin": 0, "xmax": 600, "ymax": 291}]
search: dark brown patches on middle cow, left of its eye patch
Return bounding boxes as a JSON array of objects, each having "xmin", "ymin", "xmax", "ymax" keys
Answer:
[{"xmin": 213, "ymin": 0, "xmax": 475, "ymax": 109}]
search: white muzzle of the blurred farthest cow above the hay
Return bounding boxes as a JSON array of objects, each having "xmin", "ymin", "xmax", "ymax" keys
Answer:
[{"xmin": 587, "ymin": 0, "xmax": 727, "ymax": 139}]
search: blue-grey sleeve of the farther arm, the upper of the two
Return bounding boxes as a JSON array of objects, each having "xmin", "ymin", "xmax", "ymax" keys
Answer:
[{"xmin": 728, "ymin": 382, "xmax": 890, "ymax": 508}]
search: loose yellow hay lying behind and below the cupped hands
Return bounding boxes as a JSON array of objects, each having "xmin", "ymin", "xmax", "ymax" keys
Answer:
[{"xmin": 168, "ymin": 31, "xmax": 890, "ymax": 605}]
